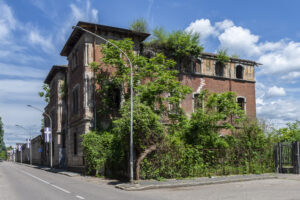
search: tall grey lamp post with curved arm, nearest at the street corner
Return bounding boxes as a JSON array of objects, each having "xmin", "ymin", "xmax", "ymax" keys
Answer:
[{"xmin": 72, "ymin": 26, "xmax": 133, "ymax": 183}]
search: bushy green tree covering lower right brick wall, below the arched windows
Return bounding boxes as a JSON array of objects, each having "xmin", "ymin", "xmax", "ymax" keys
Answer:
[{"xmin": 185, "ymin": 90, "xmax": 245, "ymax": 148}]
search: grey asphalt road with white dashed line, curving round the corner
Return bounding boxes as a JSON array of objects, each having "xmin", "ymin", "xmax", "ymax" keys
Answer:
[{"xmin": 0, "ymin": 162, "xmax": 300, "ymax": 200}]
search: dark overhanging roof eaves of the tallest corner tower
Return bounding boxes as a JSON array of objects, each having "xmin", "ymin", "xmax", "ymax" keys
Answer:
[{"xmin": 60, "ymin": 21, "xmax": 150, "ymax": 56}]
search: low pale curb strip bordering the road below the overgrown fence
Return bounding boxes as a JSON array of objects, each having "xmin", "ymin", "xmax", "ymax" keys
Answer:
[{"xmin": 115, "ymin": 175, "xmax": 278, "ymax": 191}]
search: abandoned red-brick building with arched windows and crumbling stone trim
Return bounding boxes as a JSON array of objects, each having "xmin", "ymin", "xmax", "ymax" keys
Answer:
[{"xmin": 40, "ymin": 22, "xmax": 257, "ymax": 170}]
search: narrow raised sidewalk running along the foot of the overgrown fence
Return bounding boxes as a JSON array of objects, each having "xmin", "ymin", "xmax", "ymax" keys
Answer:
[{"xmin": 116, "ymin": 174, "xmax": 279, "ymax": 191}]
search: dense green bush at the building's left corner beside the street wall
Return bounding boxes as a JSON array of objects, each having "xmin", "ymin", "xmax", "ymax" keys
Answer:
[{"xmin": 81, "ymin": 131, "xmax": 113, "ymax": 174}]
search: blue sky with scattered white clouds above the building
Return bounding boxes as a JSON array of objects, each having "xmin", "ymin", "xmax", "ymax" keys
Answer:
[{"xmin": 0, "ymin": 0, "xmax": 300, "ymax": 145}]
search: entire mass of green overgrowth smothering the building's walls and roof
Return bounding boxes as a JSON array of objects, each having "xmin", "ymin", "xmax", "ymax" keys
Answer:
[{"xmin": 83, "ymin": 37, "xmax": 273, "ymax": 179}]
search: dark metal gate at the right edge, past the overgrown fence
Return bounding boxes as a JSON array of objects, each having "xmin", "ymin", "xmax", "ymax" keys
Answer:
[{"xmin": 274, "ymin": 142, "xmax": 300, "ymax": 174}]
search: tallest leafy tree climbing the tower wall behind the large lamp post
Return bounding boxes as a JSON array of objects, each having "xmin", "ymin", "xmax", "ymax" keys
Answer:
[{"xmin": 86, "ymin": 39, "xmax": 191, "ymax": 177}]
